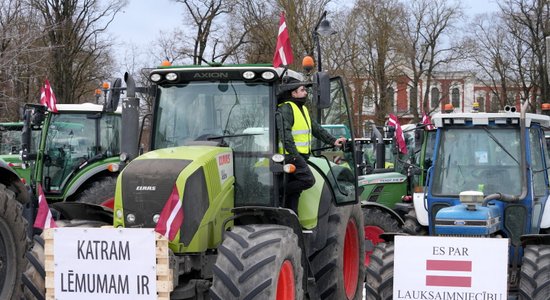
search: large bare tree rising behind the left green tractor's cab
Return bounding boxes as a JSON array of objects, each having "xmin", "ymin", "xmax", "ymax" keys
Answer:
[{"xmin": 30, "ymin": 0, "xmax": 126, "ymax": 103}]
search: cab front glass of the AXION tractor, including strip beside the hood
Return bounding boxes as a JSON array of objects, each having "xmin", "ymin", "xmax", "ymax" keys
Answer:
[{"xmin": 153, "ymin": 80, "xmax": 274, "ymax": 206}]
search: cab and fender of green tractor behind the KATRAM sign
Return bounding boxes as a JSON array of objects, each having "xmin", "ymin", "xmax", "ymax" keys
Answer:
[{"xmin": 24, "ymin": 103, "xmax": 122, "ymax": 201}]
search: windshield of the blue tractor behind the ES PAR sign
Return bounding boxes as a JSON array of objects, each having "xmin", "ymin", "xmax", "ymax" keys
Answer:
[{"xmin": 432, "ymin": 126, "xmax": 521, "ymax": 196}]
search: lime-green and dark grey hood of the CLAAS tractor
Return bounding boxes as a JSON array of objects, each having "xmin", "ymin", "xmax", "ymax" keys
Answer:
[{"xmin": 114, "ymin": 146, "xmax": 233, "ymax": 248}]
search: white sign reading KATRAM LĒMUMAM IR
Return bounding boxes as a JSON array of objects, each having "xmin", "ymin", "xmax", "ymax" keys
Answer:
[{"xmin": 53, "ymin": 227, "xmax": 157, "ymax": 300}]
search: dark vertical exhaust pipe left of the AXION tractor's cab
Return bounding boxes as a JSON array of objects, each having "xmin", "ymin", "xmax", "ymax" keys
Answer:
[{"xmin": 120, "ymin": 72, "xmax": 139, "ymax": 164}]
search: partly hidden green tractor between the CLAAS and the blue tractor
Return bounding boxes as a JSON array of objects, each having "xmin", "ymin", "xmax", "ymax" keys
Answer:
[{"xmin": 359, "ymin": 120, "xmax": 435, "ymax": 265}]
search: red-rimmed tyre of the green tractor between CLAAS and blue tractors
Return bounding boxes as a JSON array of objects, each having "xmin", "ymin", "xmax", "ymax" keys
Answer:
[{"xmin": 362, "ymin": 206, "xmax": 403, "ymax": 267}]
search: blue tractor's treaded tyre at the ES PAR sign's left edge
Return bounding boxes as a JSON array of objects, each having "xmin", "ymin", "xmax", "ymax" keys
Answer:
[{"xmin": 365, "ymin": 243, "xmax": 394, "ymax": 300}]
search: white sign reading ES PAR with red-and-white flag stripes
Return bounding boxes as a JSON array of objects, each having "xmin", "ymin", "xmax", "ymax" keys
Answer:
[{"xmin": 393, "ymin": 236, "xmax": 508, "ymax": 300}]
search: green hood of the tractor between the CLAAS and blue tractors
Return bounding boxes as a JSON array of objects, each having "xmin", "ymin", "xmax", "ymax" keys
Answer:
[{"xmin": 358, "ymin": 172, "xmax": 408, "ymax": 209}]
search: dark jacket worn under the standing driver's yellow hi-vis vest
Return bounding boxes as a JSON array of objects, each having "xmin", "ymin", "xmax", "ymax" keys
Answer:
[{"xmin": 277, "ymin": 100, "xmax": 336, "ymax": 156}]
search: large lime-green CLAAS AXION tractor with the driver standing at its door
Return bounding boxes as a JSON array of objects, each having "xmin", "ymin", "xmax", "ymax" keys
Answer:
[{"xmin": 108, "ymin": 65, "xmax": 364, "ymax": 299}]
